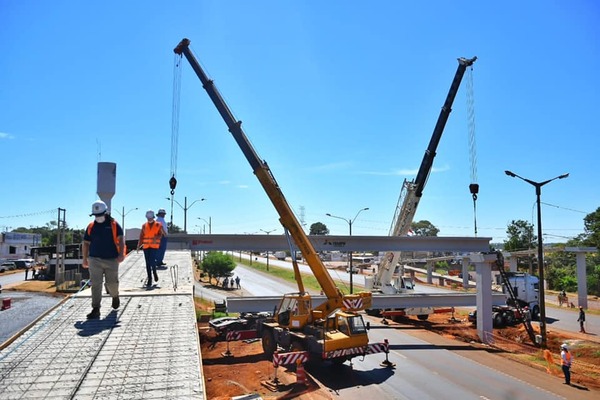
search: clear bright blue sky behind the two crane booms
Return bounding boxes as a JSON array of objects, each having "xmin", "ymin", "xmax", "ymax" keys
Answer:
[{"xmin": 0, "ymin": 0, "xmax": 600, "ymax": 242}]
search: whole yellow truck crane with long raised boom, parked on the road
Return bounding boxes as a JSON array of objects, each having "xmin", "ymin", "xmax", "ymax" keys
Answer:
[{"xmin": 174, "ymin": 39, "xmax": 387, "ymax": 363}]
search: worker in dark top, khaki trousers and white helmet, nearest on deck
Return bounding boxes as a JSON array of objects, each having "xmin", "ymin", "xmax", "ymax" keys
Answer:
[{"xmin": 82, "ymin": 200, "xmax": 125, "ymax": 319}]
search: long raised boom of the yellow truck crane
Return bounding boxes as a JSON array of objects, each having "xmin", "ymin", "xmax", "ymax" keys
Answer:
[{"xmin": 174, "ymin": 39, "xmax": 371, "ymax": 311}]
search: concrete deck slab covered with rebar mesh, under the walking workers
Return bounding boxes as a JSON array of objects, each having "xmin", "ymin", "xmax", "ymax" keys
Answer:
[{"xmin": 0, "ymin": 251, "xmax": 205, "ymax": 399}]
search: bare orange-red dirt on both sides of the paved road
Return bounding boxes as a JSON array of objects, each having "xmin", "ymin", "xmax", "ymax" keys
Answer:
[{"xmin": 199, "ymin": 304, "xmax": 600, "ymax": 400}]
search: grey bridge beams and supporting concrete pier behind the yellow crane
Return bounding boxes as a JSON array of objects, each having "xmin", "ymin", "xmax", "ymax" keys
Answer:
[{"xmin": 168, "ymin": 234, "xmax": 496, "ymax": 343}]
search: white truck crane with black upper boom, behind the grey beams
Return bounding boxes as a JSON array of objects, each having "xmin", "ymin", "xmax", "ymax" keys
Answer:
[{"xmin": 365, "ymin": 57, "xmax": 477, "ymax": 319}]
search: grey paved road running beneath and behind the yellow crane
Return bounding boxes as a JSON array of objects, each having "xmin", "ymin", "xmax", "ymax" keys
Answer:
[{"xmin": 209, "ymin": 263, "xmax": 598, "ymax": 400}]
